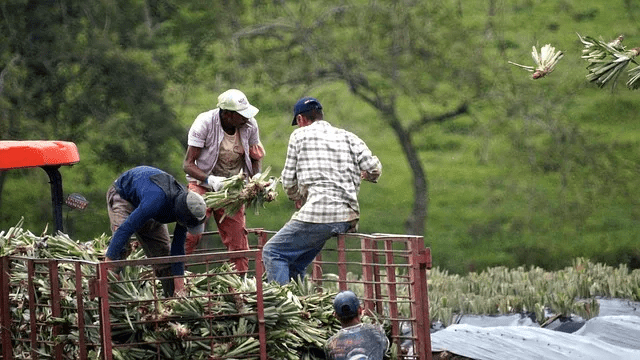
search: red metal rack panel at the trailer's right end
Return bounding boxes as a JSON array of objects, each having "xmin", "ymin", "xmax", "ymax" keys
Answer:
[{"xmin": 311, "ymin": 234, "xmax": 431, "ymax": 360}]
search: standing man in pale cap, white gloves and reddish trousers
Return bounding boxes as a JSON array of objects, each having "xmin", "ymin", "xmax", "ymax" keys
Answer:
[{"xmin": 182, "ymin": 89, "xmax": 265, "ymax": 272}]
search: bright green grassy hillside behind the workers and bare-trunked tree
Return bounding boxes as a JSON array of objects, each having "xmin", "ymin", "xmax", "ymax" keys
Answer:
[{"xmin": 2, "ymin": 0, "xmax": 640, "ymax": 273}]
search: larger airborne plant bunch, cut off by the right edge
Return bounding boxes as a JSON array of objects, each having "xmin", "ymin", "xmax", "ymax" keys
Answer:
[{"xmin": 578, "ymin": 34, "xmax": 640, "ymax": 89}]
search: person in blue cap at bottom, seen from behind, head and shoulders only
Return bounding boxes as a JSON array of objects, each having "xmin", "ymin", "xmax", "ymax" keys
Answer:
[{"xmin": 325, "ymin": 290, "xmax": 389, "ymax": 360}]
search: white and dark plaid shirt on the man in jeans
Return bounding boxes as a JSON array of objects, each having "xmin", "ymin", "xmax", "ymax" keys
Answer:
[{"xmin": 282, "ymin": 120, "xmax": 382, "ymax": 223}]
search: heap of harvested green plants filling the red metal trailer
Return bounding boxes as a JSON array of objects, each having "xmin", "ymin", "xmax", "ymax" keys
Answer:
[{"xmin": 0, "ymin": 223, "xmax": 350, "ymax": 360}]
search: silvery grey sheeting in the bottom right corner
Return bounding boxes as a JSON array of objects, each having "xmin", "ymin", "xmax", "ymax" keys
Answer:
[{"xmin": 431, "ymin": 299, "xmax": 640, "ymax": 360}]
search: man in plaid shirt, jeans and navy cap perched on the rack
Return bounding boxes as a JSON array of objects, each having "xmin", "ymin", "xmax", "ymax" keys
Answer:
[{"xmin": 262, "ymin": 97, "xmax": 382, "ymax": 284}]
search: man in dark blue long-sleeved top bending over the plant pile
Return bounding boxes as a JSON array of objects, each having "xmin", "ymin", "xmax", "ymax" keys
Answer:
[{"xmin": 105, "ymin": 166, "xmax": 207, "ymax": 296}]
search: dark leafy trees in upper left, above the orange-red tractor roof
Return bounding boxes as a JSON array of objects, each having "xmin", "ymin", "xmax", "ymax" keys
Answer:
[{"xmin": 0, "ymin": 1, "xmax": 182, "ymax": 166}]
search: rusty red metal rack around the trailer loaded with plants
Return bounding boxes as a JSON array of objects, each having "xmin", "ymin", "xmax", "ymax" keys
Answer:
[{"xmin": 0, "ymin": 229, "xmax": 432, "ymax": 360}]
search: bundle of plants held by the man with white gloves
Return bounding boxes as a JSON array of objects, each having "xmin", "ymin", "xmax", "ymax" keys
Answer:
[{"xmin": 203, "ymin": 166, "xmax": 280, "ymax": 216}]
